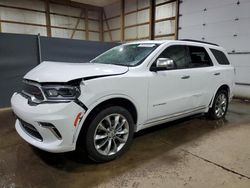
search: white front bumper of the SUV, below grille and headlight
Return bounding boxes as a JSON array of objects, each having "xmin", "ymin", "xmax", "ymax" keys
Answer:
[{"xmin": 11, "ymin": 93, "xmax": 85, "ymax": 153}]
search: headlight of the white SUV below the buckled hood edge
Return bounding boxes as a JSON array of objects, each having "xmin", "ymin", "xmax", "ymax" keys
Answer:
[{"xmin": 42, "ymin": 85, "xmax": 81, "ymax": 100}]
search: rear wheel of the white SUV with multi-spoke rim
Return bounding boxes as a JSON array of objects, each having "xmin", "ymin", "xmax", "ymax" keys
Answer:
[{"xmin": 208, "ymin": 90, "xmax": 229, "ymax": 120}]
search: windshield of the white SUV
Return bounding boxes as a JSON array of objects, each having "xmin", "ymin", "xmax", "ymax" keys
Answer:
[{"xmin": 91, "ymin": 43, "xmax": 159, "ymax": 67}]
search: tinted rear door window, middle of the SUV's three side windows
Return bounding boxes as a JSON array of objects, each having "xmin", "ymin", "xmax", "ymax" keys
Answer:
[{"xmin": 188, "ymin": 46, "xmax": 213, "ymax": 68}]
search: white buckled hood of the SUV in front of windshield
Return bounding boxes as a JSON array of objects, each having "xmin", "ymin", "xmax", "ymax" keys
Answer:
[{"xmin": 24, "ymin": 61, "xmax": 128, "ymax": 82}]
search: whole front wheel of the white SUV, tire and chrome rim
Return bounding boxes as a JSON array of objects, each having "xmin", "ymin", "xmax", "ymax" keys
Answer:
[{"xmin": 85, "ymin": 106, "xmax": 134, "ymax": 162}]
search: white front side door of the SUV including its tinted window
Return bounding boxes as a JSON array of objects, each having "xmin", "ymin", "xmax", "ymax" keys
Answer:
[{"xmin": 148, "ymin": 45, "xmax": 194, "ymax": 122}]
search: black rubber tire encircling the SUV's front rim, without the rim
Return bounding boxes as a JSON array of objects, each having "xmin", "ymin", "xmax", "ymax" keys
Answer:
[{"xmin": 85, "ymin": 106, "xmax": 135, "ymax": 162}]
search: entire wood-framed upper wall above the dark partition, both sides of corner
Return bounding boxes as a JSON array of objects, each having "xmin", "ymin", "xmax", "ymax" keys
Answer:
[{"xmin": 0, "ymin": 0, "xmax": 178, "ymax": 42}]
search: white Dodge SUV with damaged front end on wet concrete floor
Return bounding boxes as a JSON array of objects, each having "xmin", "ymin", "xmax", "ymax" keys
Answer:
[{"xmin": 11, "ymin": 41, "xmax": 234, "ymax": 162}]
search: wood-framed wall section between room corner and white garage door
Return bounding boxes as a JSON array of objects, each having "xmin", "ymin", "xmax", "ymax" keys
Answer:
[{"xmin": 103, "ymin": 0, "xmax": 178, "ymax": 42}]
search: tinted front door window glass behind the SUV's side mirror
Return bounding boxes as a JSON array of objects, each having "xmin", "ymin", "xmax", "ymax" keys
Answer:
[{"xmin": 158, "ymin": 45, "xmax": 188, "ymax": 69}]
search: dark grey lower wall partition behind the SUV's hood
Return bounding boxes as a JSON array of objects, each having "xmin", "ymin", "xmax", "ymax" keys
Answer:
[{"xmin": 0, "ymin": 33, "xmax": 118, "ymax": 108}]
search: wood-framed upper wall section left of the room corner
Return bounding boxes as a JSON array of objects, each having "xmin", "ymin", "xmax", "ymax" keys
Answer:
[{"xmin": 0, "ymin": 0, "xmax": 102, "ymax": 41}]
